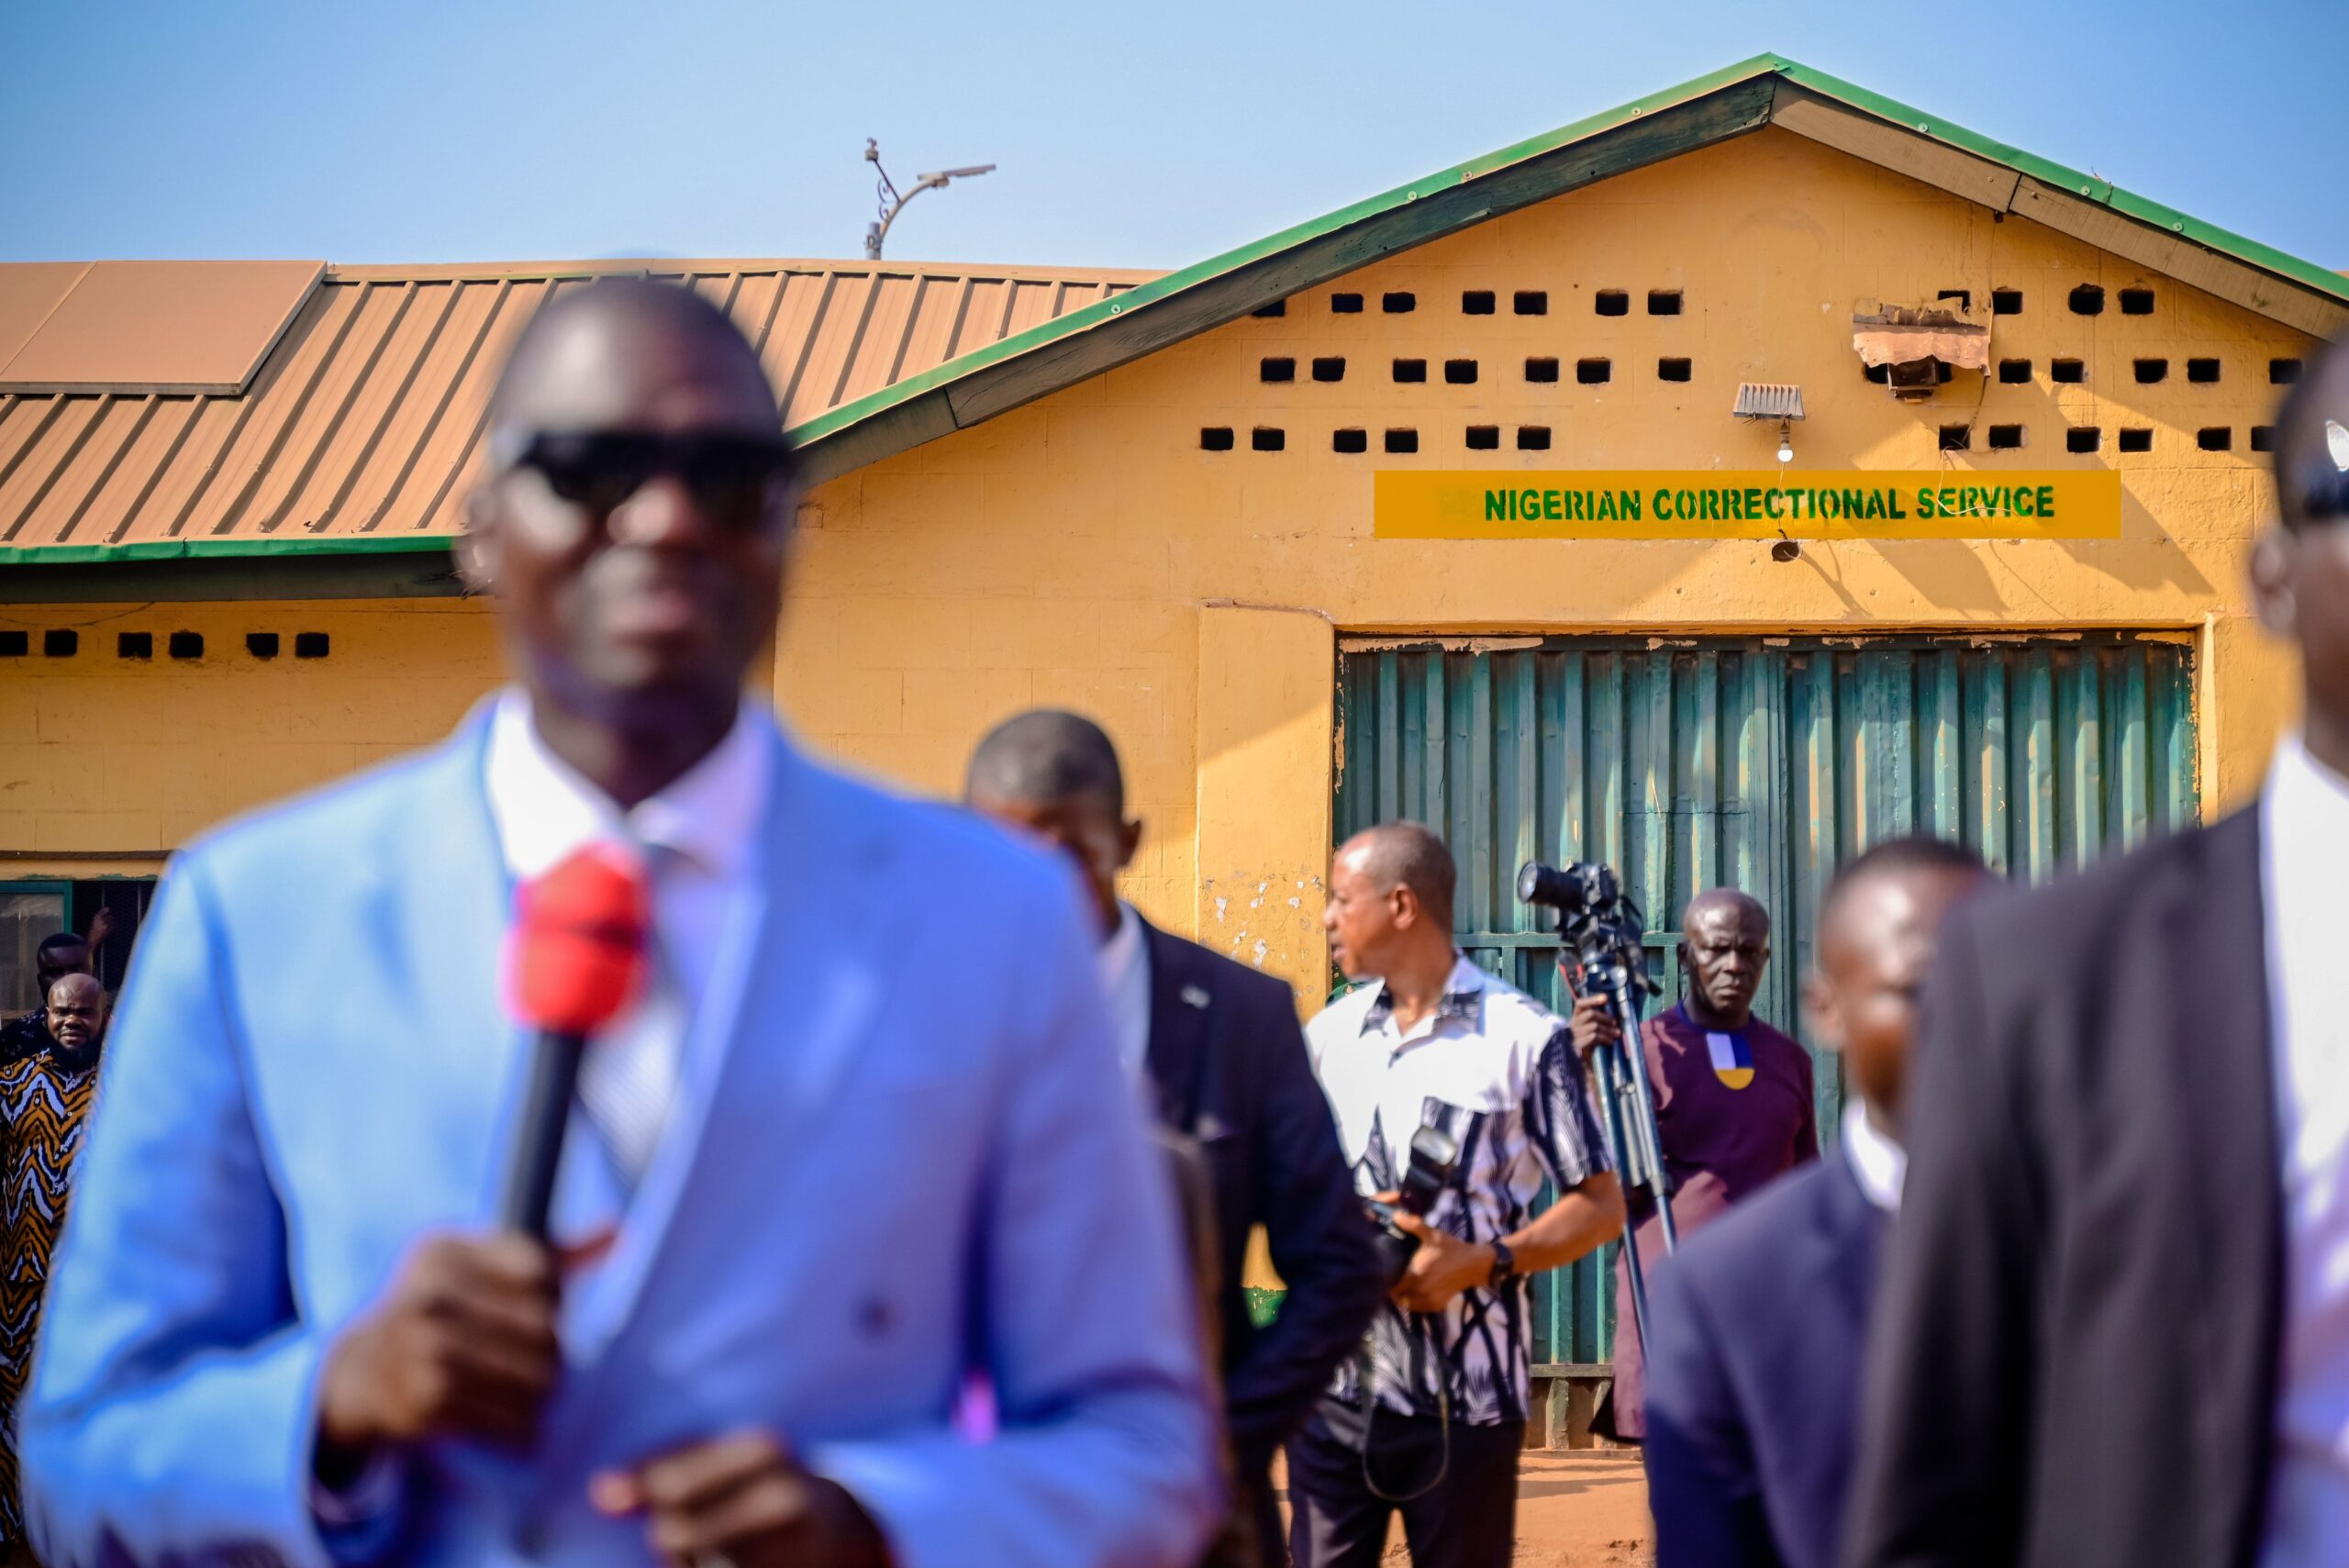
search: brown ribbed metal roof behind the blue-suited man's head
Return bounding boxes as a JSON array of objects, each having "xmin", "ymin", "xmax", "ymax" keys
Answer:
[{"xmin": 0, "ymin": 261, "xmax": 1156, "ymax": 550}]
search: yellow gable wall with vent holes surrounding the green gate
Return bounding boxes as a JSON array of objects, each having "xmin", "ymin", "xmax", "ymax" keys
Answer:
[{"xmin": 777, "ymin": 129, "xmax": 2309, "ymax": 997}]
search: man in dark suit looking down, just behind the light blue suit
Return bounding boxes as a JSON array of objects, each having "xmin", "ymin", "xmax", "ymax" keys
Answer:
[{"xmin": 965, "ymin": 709, "xmax": 1386, "ymax": 1563}]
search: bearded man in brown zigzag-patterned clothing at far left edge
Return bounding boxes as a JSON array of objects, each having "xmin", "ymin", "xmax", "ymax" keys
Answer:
[{"xmin": 0, "ymin": 974, "xmax": 106, "ymax": 1551}]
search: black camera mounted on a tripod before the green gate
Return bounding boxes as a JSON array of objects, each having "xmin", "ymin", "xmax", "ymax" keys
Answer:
[{"xmin": 1518, "ymin": 862, "xmax": 1679, "ymax": 1345}]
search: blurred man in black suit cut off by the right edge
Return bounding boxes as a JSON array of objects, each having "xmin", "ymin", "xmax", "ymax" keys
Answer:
[{"xmin": 1846, "ymin": 333, "xmax": 2349, "ymax": 1568}]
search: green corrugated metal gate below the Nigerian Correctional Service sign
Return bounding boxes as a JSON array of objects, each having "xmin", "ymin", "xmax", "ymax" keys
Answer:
[{"xmin": 1337, "ymin": 634, "xmax": 2197, "ymax": 1363}]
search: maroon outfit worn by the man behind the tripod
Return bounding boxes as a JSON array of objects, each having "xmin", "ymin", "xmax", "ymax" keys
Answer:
[{"xmin": 1614, "ymin": 1007, "xmax": 1818, "ymax": 1437}]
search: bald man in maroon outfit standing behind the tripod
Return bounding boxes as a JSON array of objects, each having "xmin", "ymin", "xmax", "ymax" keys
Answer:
[{"xmin": 1574, "ymin": 887, "xmax": 1818, "ymax": 1441}]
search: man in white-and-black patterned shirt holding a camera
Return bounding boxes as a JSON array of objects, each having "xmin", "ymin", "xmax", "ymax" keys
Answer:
[{"xmin": 1287, "ymin": 821, "xmax": 1623, "ymax": 1568}]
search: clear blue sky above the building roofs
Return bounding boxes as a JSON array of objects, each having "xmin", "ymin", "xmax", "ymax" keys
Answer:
[{"xmin": 0, "ymin": 0, "xmax": 2349, "ymax": 268}]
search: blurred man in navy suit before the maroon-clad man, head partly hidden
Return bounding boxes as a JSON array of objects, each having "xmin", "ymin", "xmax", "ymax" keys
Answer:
[{"xmin": 1647, "ymin": 838, "xmax": 1985, "ymax": 1568}]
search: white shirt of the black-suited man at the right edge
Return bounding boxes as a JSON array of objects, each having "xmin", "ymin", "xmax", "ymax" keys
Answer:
[{"xmin": 2260, "ymin": 737, "xmax": 2349, "ymax": 1568}]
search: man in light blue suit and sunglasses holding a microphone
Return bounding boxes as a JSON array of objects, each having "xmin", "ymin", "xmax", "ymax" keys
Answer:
[{"xmin": 21, "ymin": 279, "xmax": 1219, "ymax": 1568}]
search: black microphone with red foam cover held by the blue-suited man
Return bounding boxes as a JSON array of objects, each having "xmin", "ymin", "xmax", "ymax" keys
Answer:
[{"xmin": 498, "ymin": 842, "xmax": 653, "ymax": 1240}]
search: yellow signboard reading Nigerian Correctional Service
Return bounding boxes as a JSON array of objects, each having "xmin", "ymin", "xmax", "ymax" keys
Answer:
[{"xmin": 1372, "ymin": 470, "xmax": 2121, "ymax": 539}]
